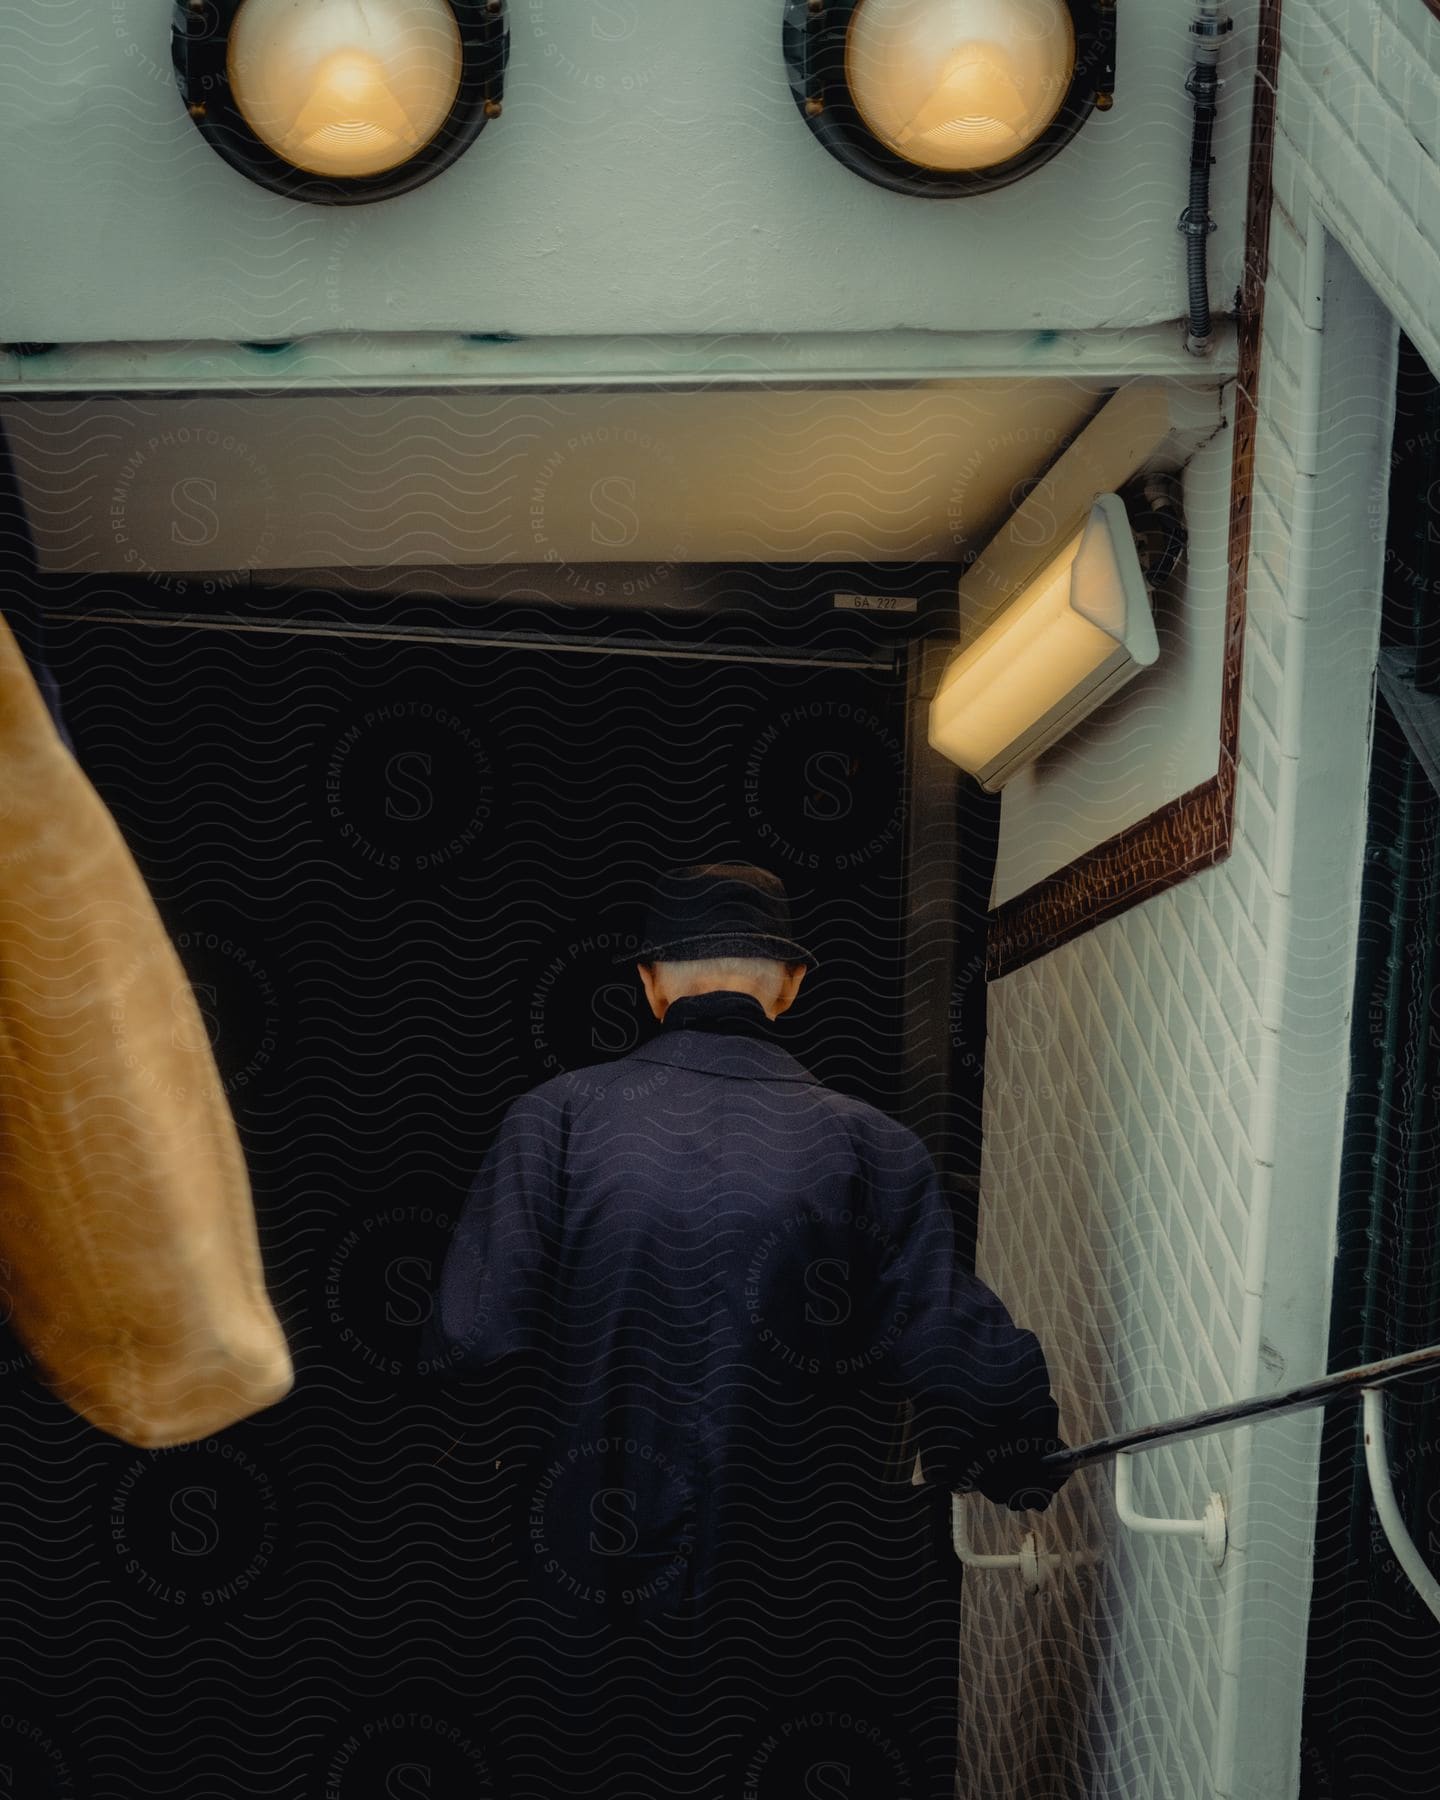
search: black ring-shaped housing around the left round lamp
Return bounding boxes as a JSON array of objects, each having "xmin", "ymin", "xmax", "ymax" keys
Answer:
[{"xmin": 171, "ymin": 0, "xmax": 509, "ymax": 207}]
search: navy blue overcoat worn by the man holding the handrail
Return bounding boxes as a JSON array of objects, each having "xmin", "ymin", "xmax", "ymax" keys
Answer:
[{"xmin": 423, "ymin": 992, "xmax": 1060, "ymax": 1618}]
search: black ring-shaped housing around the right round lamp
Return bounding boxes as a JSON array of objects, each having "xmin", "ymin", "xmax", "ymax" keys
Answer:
[{"xmin": 785, "ymin": 0, "xmax": 1114, "ymax": 200}]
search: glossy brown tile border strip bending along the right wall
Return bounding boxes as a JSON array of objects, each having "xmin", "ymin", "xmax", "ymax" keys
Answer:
[{"xmin": 985, "ymin": 0, "xmax": 1281, "ymax": 981}]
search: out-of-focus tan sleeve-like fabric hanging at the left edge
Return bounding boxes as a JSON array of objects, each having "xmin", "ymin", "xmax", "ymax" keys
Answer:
[{"xmin": 0, "ymin": 617, "xmax": 295, "ymax": 1447}]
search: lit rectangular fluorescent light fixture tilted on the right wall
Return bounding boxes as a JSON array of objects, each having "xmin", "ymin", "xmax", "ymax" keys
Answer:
[{"xmin": 929, "ymin": 493, "xmax": 1159, "ymax": 792}]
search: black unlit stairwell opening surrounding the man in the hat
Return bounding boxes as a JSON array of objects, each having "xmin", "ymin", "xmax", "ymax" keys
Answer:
[{"xmin": 0, "ymin": 435, "xmax": 983, "ymax": 1800}]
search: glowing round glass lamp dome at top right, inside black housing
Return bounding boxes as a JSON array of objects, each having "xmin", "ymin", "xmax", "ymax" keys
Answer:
[{"xmin": 846, "ymin": 0, "xmax": 1075, "ymax": 171}]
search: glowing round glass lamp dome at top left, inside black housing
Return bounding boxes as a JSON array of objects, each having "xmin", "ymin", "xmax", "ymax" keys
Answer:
[{"xmin": 227, "ymin": 0, "xmax": 463, "ymax": 176}]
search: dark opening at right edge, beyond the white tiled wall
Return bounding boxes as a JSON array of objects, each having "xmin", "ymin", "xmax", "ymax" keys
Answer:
[{"xmin": 1300, "ymin": 337, "xmax": 1440, "ymax": 1800}]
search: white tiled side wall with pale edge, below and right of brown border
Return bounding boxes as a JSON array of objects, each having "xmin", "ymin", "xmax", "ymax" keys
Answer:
[{"xmin": 959, "ymin": 0, "xmax": 1440, "ymax": 1800}]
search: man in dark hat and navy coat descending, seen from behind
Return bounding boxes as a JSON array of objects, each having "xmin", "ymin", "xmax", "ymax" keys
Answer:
[{"xmin": 425, "ymin": 864, "xmax": 1060, "ymax": 1800}]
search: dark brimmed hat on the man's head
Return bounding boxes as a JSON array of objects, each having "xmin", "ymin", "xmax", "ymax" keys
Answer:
[{"xmin": 616, "ymin": 862, "xmax": 819, "ymax": 968}]
